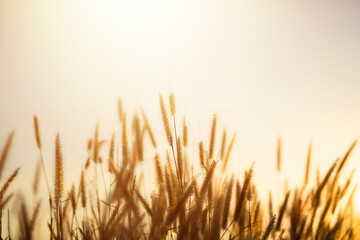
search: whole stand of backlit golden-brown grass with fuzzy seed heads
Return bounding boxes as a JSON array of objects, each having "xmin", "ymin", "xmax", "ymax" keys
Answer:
[{"xmin": 0, "ymin": 93, "xmax": 360, "ymax": 240}]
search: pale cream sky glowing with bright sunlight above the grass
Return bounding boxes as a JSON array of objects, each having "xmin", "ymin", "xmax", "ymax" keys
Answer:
[{"xmin": 0, "ymin": 0, "xmax": 360, "ymax": 227}]
